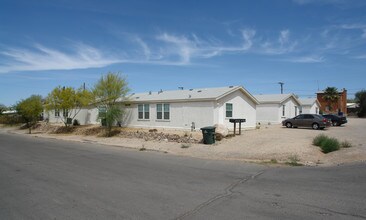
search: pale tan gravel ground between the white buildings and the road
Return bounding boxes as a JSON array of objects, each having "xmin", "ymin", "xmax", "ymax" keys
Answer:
[{"xmin": 1, "ymin": 118, "xmax": 366, "ymax": 166}]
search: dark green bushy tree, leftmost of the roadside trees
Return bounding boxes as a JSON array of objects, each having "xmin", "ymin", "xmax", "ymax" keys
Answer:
[{"xmin": 15, "ymin": 95, "xmax": 43, "ymax": 134}]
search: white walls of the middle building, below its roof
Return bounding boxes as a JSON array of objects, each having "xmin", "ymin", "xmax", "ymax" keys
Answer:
[{"xmin": 257, "ymin": 97, "xmax": 300, "ymax": 124}]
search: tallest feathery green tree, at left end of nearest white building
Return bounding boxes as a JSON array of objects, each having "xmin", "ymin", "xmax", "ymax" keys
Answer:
[{"xmin": 93, "ymin": 72, "xmax": 129, "ymax": 136}]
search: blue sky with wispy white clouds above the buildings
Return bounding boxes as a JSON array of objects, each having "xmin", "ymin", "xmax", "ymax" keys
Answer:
[{"xmin": 0, "ymin": 0, "xmax": 366, "ymax": 105}]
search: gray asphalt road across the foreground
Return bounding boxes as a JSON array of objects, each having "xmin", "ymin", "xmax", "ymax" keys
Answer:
[{"xmin": 0, "ymin": 133, "xmax": 366, "ymax": 219}]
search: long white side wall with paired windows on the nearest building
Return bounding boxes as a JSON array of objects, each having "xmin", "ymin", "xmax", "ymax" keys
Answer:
[{"xmin": 123, "ymin": 101, "xmax": 214, "ymax": 129}]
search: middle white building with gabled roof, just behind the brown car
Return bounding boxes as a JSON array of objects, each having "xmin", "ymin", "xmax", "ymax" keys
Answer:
[{"xmin": 254, "ymin": 94, "xmax": 301, "ymax": 124}]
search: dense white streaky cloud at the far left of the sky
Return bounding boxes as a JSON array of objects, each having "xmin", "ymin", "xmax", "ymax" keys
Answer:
[{"xmin": 0, "ymin": 43, "xmax": 121, "ymax": 73}]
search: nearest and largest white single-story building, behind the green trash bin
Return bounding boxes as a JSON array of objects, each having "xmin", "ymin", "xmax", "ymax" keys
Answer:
[{"xmin": 120, "ymin": 86, "xmax": 258, "ymax": 129}]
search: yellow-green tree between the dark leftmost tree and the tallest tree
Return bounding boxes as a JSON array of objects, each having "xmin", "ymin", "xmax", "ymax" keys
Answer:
[{"xmin": 45, "ymin": 86, "xmax": 93, "ymax": 127}]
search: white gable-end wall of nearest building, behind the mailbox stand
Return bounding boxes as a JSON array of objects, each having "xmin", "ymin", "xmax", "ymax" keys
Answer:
[{"xmin": 214, "ymin": 91, "xmax": 257, "ymax": 130}]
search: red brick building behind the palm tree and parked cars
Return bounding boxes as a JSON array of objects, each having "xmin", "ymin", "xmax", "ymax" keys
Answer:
[{"xmin": 316, "ymin": 89, "xmax": 347, "ymax": 114}]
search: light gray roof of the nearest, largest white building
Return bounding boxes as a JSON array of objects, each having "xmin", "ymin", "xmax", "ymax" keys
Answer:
[{"xmin": 120, "ymin": 86, "xmax": 258, "ymax": 103}]
